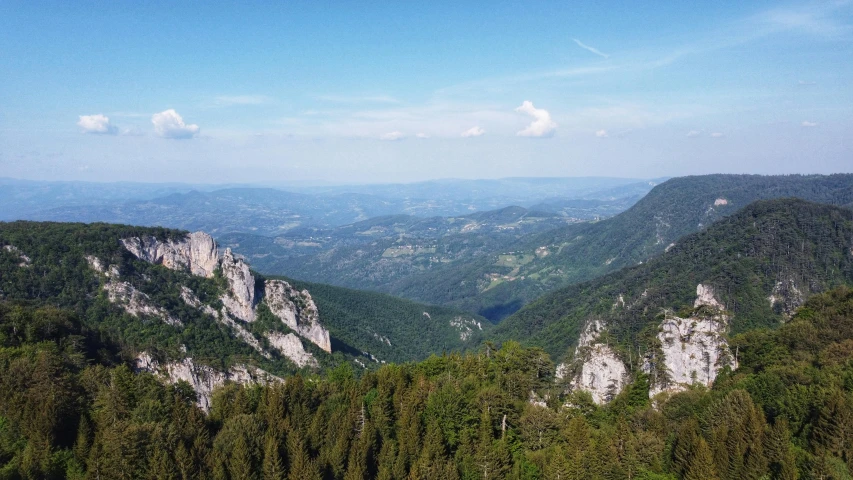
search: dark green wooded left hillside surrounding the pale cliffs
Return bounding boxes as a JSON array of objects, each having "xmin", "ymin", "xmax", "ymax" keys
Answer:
[{"xmin": 0, "ymin": 222, "xmax": 489, "ymax": 374}]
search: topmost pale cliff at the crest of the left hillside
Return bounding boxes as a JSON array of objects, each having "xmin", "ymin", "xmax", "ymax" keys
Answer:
[{"xmin": 121, "ymin": 232, "xmax": 219, "ymax": 278}]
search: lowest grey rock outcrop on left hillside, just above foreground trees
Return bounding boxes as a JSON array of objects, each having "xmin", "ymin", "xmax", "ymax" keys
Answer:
[{"xmin": 135, "ymin": 352, "xmax": 283, "ymax": 412}]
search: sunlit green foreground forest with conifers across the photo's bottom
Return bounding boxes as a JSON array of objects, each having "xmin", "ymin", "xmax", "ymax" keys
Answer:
[{"xmin": 0, "ymin": 288, "xmax": 853, "ymax": 480}]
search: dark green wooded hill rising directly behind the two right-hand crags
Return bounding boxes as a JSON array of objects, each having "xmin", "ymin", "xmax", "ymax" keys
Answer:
[{"xmin": 493, "ymin": 199, "xmax": 853, "ymax": 357}]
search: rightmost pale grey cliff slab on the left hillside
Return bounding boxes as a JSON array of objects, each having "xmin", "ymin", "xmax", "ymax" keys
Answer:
[{"xmin": 264, "ymin": 280, "xmax": 332, "ymax": 352}]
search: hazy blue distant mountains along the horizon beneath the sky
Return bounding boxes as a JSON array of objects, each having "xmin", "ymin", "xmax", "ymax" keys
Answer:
[{"xmin": 0, "ymin": 178, "xmax": 658, "ymax": 231}]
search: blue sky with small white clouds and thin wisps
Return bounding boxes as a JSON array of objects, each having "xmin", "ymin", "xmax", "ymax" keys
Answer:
[{"xmin": 0, "ymin": 1, "xmax": 853, "ymax": 184}]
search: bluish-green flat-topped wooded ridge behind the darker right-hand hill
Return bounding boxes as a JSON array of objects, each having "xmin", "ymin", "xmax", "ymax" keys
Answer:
[{"xmin": 388, "ymin": 174, "xmax": 853, "ymax": 320}]
